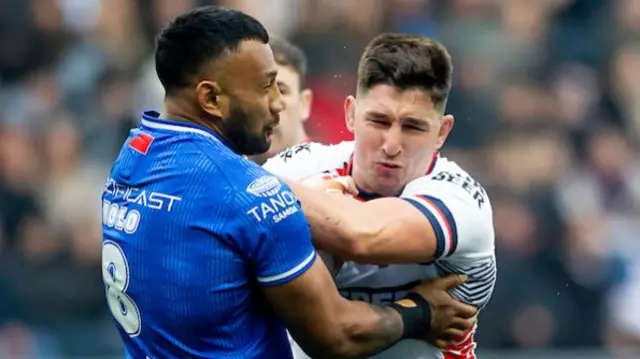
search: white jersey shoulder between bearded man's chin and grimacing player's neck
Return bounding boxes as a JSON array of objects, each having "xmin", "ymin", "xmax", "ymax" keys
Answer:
[{"xmin": 263, "ymin": 141, "xmax": 354, "ymax": 180}]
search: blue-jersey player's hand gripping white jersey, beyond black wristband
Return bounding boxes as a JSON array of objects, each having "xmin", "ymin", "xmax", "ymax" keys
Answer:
[{"xmin": 413, "ymin": 274, "xmax": 478, "ymax": 348}]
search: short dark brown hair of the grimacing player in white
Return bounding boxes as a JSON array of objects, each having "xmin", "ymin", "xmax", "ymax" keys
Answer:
[{"xmin": 358, "ymin": 33, "xmax": 453, "ymax": 109}]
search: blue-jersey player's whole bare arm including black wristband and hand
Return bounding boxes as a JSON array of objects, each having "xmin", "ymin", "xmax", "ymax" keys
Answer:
[{"xmin": 264, "ymin": 259, "xmax": 476, "ymax": 358}]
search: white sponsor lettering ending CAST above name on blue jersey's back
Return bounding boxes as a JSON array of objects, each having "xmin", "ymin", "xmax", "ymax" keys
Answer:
[{"xmin": 104, "ymin": 178, "xmax": 182, "ymax": 212}]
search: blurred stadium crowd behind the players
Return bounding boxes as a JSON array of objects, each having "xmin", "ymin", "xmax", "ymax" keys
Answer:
[{"xmin": 0, "ymin": 0, "xmax": 640, "ymax": 359}]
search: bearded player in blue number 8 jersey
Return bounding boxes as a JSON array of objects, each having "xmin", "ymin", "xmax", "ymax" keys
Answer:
[{"xmin": 102, "ymin": 6, "xmax": 475, "ymax": 359}]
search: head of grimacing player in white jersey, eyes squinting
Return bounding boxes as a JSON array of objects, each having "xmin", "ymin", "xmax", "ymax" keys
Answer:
[{"xmin": 345, "ymin": 33, "xmax": 453, "ymax": 196}]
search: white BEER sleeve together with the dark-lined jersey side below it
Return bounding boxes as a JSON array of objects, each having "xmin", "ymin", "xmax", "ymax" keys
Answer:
[{"xmin": 403, "ymin": 171, "xmax": 497, "ymax": 309}]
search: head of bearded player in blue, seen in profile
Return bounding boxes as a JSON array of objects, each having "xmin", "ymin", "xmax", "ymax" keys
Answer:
[{"xmin": 155, "ymin": 6, "xmax": 284, "ymax": 154}]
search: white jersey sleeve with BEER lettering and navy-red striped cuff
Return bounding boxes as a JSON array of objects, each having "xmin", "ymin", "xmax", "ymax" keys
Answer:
[{"xmin": 402, "ymin": 171, "xmax": 494, "ymax": 262}]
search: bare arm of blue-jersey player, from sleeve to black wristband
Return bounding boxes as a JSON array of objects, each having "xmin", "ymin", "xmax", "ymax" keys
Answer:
[{"xmin": 265, "ymin": 260, "xmax": 403, "ymax": 358}]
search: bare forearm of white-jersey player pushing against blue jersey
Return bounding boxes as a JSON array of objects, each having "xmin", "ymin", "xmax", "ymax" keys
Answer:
[{"xmin": 288, "ymin": 183, "xmax": 441, "ymax": 264}]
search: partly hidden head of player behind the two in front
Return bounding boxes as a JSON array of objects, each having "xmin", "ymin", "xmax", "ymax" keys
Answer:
[{"xmin": 252, "ymin": 38, "xmax": 313, "ymax": 163}]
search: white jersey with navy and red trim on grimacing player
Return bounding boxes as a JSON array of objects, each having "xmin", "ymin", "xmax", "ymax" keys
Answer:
[{"xmin": 263, "ymin": 142, "xmax": 497, "ymax": 359}]
